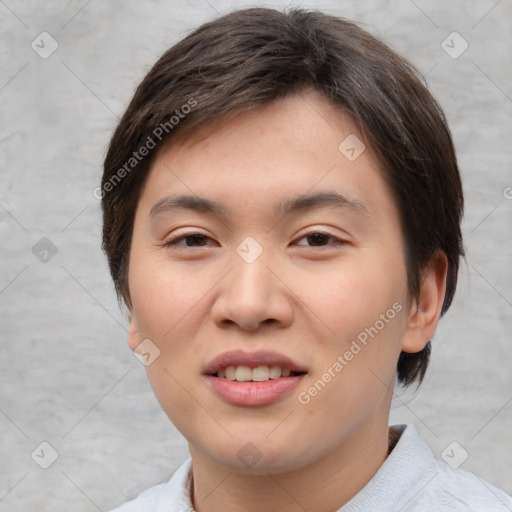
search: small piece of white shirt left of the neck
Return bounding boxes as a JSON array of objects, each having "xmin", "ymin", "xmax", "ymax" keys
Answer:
[{"xmin": 110, "ymin": 459, "xmax": 193, "ymax": 512}]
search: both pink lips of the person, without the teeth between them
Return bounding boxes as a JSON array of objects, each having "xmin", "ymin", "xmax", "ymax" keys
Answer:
[{"xmin": 203, "ymin": 350, "xmax": 307, "ymax": 407}]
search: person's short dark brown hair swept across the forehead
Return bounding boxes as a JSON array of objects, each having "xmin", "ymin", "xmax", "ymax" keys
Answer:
[{"xmin": 101, "ymin": 8, "xmax": 464, "ymax": 385}]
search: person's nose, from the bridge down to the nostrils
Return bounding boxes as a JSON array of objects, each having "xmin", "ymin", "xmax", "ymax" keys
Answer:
[{"xmin": 211, "ymin": 247, "xmax": 293, "ymax": 331}]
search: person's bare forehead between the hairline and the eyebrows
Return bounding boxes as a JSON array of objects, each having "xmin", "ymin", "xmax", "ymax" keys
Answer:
[{"xmin": 141, "ymin": 91, "xmax": 398, "ymax": 222}]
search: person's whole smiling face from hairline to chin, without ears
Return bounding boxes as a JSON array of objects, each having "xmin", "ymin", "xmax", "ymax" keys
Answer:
[{"xmin": 128, "ymin": 92, "xmax": 416, "ymax": 473}]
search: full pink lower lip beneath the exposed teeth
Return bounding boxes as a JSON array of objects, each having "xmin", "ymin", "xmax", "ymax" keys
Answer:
[{"xmin": 206, "ymin": 375, "xmax": 304, "ymax": 407}]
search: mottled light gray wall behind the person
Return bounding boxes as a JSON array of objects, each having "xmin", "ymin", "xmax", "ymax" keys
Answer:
[{"xmin": 0, "ymin": 0, "xmax": 512, "ymax": 512}]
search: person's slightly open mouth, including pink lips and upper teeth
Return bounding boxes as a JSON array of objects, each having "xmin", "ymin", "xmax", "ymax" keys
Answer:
[{"xmin": 203, "ymin": 351, "xmax": 308, "ymax": 407}]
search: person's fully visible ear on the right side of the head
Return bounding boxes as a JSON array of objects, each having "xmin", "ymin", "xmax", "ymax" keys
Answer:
[{"xmin": 402, "ymin": 251, "xmax": 448, "ymax": 353}]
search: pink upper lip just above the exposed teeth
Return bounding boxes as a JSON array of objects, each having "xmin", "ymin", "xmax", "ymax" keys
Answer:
[{"xmin": 204, "ymin": 350, "xmax": 306, "ymax": 375}]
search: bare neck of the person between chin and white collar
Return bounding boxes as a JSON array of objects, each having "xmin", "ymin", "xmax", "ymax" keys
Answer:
[{"xmin": 190, "ymin": 418, "xmax": 389, "ymax": 512}]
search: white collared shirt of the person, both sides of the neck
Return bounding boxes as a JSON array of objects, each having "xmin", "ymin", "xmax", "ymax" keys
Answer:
[{"xmin": 111, "ymin": 424, "xmax": 512, "ymax": 512}]
